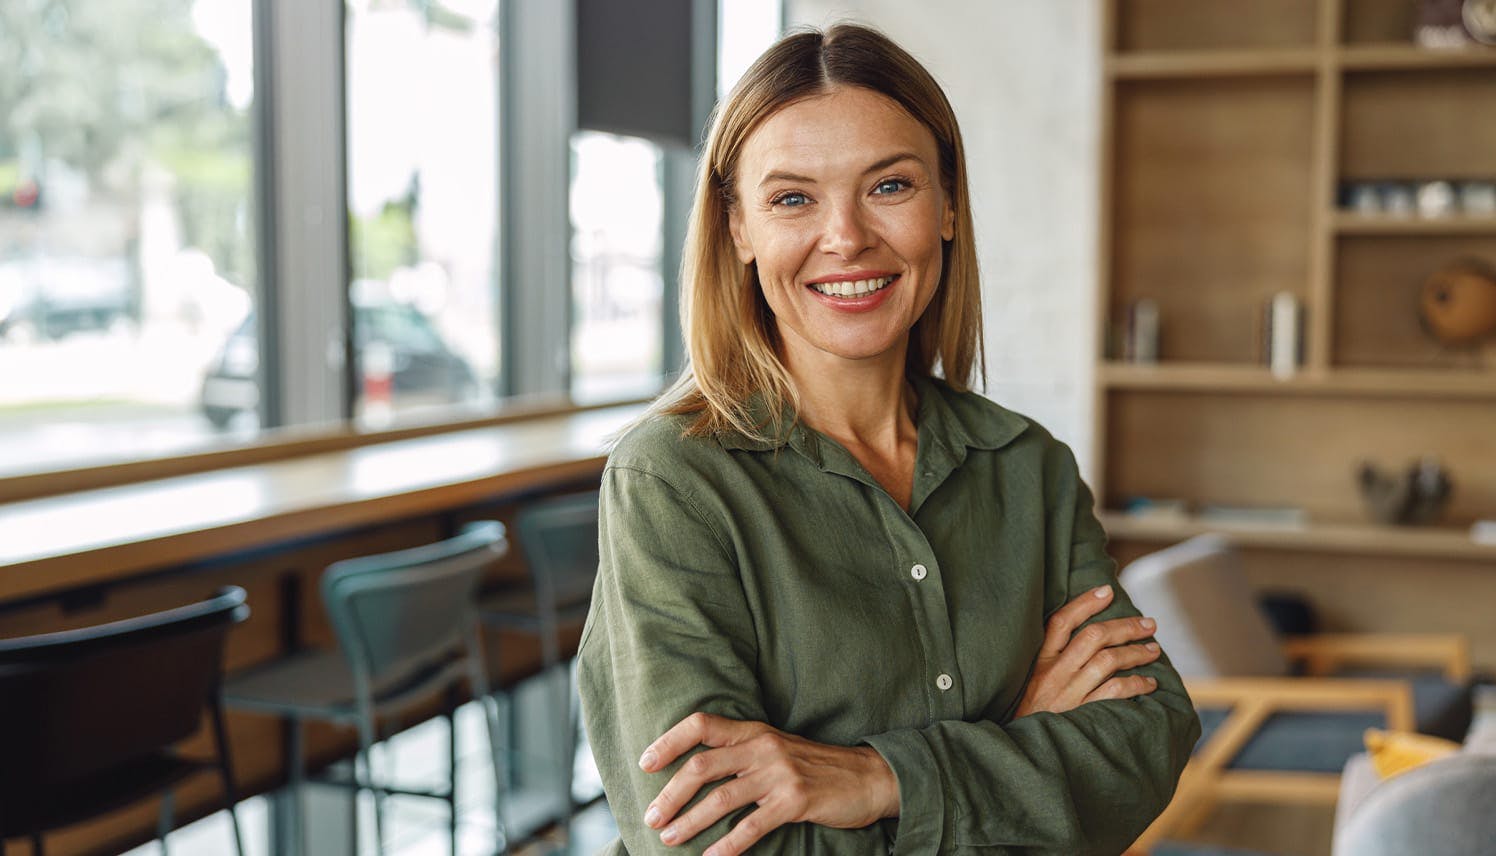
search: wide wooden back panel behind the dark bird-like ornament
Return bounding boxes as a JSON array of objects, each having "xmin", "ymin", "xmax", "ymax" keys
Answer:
[{"xmin": 1106, "ymin": 391, "xmax": 1496, "ymax": 525}]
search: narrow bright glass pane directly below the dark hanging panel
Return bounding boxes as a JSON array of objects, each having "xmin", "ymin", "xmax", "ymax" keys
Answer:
[{"xmin": 571, "ymin": 132, "xmax": 664, "ymax": 401}]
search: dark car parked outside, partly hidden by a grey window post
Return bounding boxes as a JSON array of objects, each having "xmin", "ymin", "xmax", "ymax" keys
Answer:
[{"xmin": 202, "ymin": 302, "xmax": 479, "ymax": 429}]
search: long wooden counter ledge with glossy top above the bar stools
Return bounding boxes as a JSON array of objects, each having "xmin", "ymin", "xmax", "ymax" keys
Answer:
[{"xmin": 0, "ymin": 403, "xmax": 645, "ymax": 600}]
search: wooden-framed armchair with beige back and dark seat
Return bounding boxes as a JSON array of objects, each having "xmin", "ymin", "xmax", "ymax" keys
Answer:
[{"xmin": 1121, "ymin": 534, "xmax": 1471, "ymax": 850}]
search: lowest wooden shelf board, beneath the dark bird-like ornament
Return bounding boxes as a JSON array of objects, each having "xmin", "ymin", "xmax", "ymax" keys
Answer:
[{"xmin": 1100, "ymin": 512, "xmax": 1496, "ymax": 560}]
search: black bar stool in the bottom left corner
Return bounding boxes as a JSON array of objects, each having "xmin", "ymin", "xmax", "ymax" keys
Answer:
[{"xmin": 0, "ymin": 587, "xmax": 250, "ymax": 856}]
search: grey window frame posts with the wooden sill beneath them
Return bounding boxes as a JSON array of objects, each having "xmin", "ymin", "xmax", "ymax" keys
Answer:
[{"xmin": 0, "ymin": 0, "xmax": 730, "ymax": 493}]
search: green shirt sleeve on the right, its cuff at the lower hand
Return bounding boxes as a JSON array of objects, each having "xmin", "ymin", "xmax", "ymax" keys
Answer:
[{"xmin": 866, "ymin": 443, "xmax": 1200, "ymax": 856}]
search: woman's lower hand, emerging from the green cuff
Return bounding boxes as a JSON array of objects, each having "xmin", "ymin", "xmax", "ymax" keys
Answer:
[{"xmin": 639, "ymin": 714, "xmax": 899, "ymax": 856}]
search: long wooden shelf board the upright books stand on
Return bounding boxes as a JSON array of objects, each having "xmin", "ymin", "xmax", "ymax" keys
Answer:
[{"xmin": 1100, "ymin": 362, "xmax": 1496, "ymax": 400}]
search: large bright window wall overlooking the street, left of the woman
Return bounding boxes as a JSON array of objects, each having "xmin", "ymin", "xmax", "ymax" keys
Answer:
[{"xmin": 0, "ymin": 0, "xmax": 781, "ymax": 477}]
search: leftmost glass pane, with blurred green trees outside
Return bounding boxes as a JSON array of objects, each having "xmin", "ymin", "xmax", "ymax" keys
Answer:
[{"xmin": 0, "ymin": 0, "xmax": 256, "ymax": 474}]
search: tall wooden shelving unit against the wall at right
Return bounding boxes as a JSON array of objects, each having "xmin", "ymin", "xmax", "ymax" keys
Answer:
[{"xmin": 1092, "ymin": 0, "xmax": 1496, "ymax": 669}]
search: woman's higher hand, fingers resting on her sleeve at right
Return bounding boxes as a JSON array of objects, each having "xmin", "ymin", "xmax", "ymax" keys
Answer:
[{"xmin": 1014, "ymin": 585, "xmax": 1159, "ymax": 717}]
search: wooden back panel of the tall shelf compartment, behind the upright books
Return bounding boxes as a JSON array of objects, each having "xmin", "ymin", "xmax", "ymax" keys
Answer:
[{"xmin": 1109, "ymin": 78, "xmax": 1313, "ymax": 362}]
